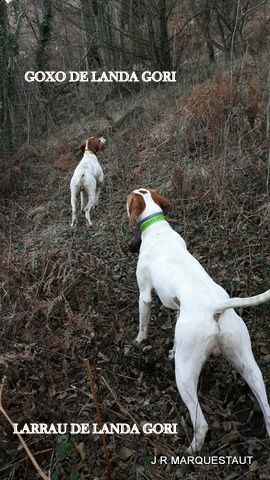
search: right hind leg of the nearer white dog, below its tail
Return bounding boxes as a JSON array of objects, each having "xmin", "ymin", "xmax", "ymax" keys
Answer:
[{"xmin": 219, "ymin": 309, "xmax": 270, "ymax": 436}]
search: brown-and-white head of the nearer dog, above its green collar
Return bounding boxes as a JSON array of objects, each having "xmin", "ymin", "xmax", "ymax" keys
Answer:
[{"xmin": 127, "ymin": 188, "xmax": 171, "ymax": 226}]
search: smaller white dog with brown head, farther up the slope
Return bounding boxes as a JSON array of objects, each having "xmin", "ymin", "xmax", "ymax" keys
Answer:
[{"xmin": 70, "ymin": 137, "xmax": 106, "ymax": 227}]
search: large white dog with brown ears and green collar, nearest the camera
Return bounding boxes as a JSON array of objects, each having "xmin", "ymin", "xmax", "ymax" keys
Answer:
[{"xmin": 127, "ymin": 188, "xmax": 270, "ymax": 452}]
